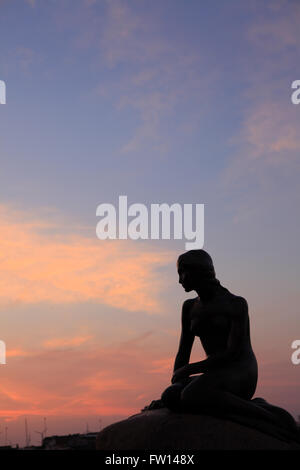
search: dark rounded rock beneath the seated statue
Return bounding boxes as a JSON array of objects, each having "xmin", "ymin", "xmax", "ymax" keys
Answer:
[{"xmin": 96, "ymin": 408, "xmax": 300, "ymax": 451}]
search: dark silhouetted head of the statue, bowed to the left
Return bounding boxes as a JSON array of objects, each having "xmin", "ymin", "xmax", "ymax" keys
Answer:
[{"xmin": 177, "ymin": 250, "xmax": 218, "ymax": 292}]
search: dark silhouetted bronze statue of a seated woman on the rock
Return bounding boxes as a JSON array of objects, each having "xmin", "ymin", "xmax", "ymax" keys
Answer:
[{"xmin": 142, "ymin": 250, "xmax": 298, "ymax": 439}]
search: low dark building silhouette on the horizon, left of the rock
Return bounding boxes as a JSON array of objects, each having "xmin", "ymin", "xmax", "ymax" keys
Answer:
[{"xmin": 42, "ymin": 432, "xmax": 98, "ymax": 450}]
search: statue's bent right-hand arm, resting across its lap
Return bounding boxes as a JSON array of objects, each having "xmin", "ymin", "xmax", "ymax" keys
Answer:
[{"xmin": 188, "ymin": 297, "xmax": 249, "ymax": 375}]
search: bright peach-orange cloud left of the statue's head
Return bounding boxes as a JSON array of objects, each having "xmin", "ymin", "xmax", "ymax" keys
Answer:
[{"xmin": 0, "ymin": 205, "xmax": 175, "ymax": 313}]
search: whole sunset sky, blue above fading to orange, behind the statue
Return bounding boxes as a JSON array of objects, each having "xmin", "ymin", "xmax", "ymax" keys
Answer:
[{"xmin": 0, "ymin": 0, "xmax": 300, "ymax": 445}]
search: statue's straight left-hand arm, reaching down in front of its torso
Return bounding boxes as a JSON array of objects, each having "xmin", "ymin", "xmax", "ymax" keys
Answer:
[{"xmin": 174, "ymin": 299, "xmax": 195, "ymax": 371}]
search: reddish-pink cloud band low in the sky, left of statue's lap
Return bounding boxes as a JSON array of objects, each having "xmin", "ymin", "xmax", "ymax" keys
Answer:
[{"xmin": 0, "ymin": 333, "xmax": 171, "ymax": 418}]
